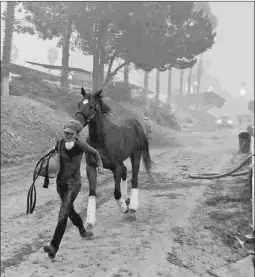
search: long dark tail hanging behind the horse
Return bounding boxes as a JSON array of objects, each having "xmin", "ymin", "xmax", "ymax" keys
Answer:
[{"xmin": 135, "ymin": 121, "xmax": 159, "ymax": 184}]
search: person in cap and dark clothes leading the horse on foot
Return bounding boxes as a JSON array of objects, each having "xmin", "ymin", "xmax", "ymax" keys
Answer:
[{"xmin": 44, "ymin": 120, "xmax": 104, "ymax": 259}]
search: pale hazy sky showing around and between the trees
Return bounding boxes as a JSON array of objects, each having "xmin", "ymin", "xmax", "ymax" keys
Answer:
[{"xmin": 1, "ymin": 2, "xmax": 254, "ymax": 98}]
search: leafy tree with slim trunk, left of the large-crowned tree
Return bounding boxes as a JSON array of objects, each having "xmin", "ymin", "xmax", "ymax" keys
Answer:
[{"xmin": 16, "ymin": 2, "xmax": 73, "ymax": 87}]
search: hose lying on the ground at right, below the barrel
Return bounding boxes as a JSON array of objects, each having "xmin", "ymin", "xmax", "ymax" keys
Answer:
[{"xmin": 188, "ymin": 154, "xmax": 254, "ymax": 180}]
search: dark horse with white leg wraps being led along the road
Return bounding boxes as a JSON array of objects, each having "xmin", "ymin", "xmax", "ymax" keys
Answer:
[{"xmin": 75, "ymin": 88, "xmax": 155, "ymax": 229}]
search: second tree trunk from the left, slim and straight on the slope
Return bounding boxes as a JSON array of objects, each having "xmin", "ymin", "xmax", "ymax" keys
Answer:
[{"xmin": 60, "ymin": 15, "xmax": 72, "ymax": 88}]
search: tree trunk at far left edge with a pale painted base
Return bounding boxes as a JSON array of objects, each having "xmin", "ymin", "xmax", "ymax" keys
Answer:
[{"xmin": 1, "ymin": 2, "xmax": 16, "ymax": 97}]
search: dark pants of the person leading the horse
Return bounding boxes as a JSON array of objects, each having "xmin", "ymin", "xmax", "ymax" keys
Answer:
[{"xmin": 51, "ymin": 183, "xmax": 83, "ymax": 250}]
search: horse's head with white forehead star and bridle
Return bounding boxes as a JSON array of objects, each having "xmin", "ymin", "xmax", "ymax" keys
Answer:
[{"xmin": 76, "ymin": 87, "xmax": 102, "ymax": 127}]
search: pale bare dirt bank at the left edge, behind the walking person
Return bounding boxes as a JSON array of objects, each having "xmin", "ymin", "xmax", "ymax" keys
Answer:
[{"xmin": 1, "ymin": 96, "xmax": 69, "ymax": 165}]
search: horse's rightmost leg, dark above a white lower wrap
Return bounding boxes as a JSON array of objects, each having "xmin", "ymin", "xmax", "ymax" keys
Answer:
[{"xmin": 129, "ymin": 151, "xmax": 142, "ymax": 212}]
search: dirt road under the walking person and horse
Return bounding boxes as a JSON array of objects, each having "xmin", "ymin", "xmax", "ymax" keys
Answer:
[{"xmin": 1, "ymin": 128, "xmax": 251, "ymax": 277}]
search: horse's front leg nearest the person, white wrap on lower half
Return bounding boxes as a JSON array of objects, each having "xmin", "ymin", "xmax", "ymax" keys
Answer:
[{"xmin": 85, "ymin": 164, "xmax": 97, "ymax": 231}]
